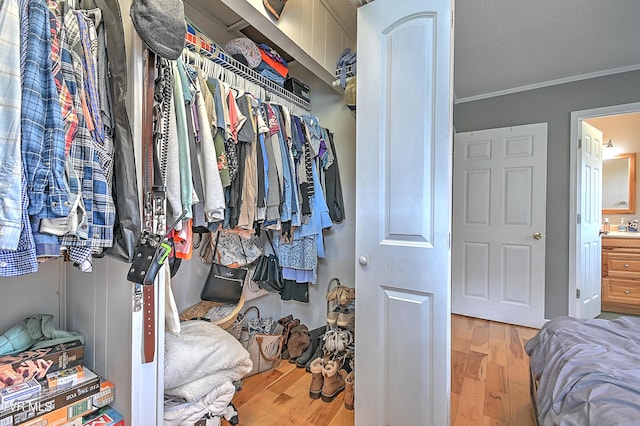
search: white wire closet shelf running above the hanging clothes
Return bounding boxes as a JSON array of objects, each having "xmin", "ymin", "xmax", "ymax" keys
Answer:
[{"xmin": 185, "ymin": 23, "xmax": 311, "ymax": 111}]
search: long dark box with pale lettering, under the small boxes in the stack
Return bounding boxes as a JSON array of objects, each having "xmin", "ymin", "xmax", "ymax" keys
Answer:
[{"xmin": 0, "ymin": 367, "xmax": 100, "ymax": 425}]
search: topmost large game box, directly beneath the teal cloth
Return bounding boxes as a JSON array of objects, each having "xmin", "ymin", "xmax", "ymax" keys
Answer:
[{"xmin": 0, "ymin": 340, "xmax": 84, "ymax": 388}]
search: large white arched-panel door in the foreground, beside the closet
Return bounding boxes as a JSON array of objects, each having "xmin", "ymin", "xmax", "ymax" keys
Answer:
[{"xmin": 355, "ymin": 0, "xmax": 453, "ymax": 426}]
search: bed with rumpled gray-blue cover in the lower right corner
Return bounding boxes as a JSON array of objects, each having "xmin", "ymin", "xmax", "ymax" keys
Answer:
[{"xmin": 525, "ymin": 316, "xmax": 640, "ymax": 426}]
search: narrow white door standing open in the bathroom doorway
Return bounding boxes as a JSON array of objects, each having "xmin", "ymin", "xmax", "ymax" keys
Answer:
[{"xmin": 576, "ymin": 121, "xmax": 602, "ymax": 318}]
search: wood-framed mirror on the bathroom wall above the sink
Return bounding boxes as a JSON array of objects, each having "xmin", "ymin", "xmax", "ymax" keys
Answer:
[{"xmin": 602, "ymin": 153, "xmax": 636, "ymax": 214}]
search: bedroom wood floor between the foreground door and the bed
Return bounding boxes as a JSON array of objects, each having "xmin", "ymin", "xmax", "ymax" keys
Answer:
[{"xmin": 451, "ymin": 315, "xmax": 538, "ymax": 426}]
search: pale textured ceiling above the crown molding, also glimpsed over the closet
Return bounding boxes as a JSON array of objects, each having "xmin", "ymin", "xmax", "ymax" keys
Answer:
[{"xmin": 322, "ymin": 0, "xmax": 640, "ymax": 102}]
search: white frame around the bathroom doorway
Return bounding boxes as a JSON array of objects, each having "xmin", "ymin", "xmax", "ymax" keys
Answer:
[{"xmin": 568, "ymin": 102, "xmax": 640, "ymax": 317}]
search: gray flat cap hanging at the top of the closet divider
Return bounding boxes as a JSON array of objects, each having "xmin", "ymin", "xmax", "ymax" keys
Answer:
[{"xmin": 129, "ymin": 0, "xmax": 187, "ymax": 59}]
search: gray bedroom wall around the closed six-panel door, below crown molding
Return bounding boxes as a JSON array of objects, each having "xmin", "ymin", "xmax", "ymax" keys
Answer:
[{"xmin": 453, "ymin": 71, "xmax": 640, "ymax": 318}]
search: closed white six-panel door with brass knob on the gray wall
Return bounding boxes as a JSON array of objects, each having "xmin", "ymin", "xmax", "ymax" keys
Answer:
[{"xmin": 451, "ymin": 123, "xmax": 547, "ymax": 327}]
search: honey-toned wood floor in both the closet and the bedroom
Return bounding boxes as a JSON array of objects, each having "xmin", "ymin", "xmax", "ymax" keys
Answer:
[{"xmin": 222, "ymin": 315, "xmax": 537, "ymax": 426}]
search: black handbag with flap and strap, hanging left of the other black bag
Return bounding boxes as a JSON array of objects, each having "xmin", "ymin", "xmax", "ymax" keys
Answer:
[{"xmin": 200, "ymin": 231, "xmax": 247, "ymax": 305}]
